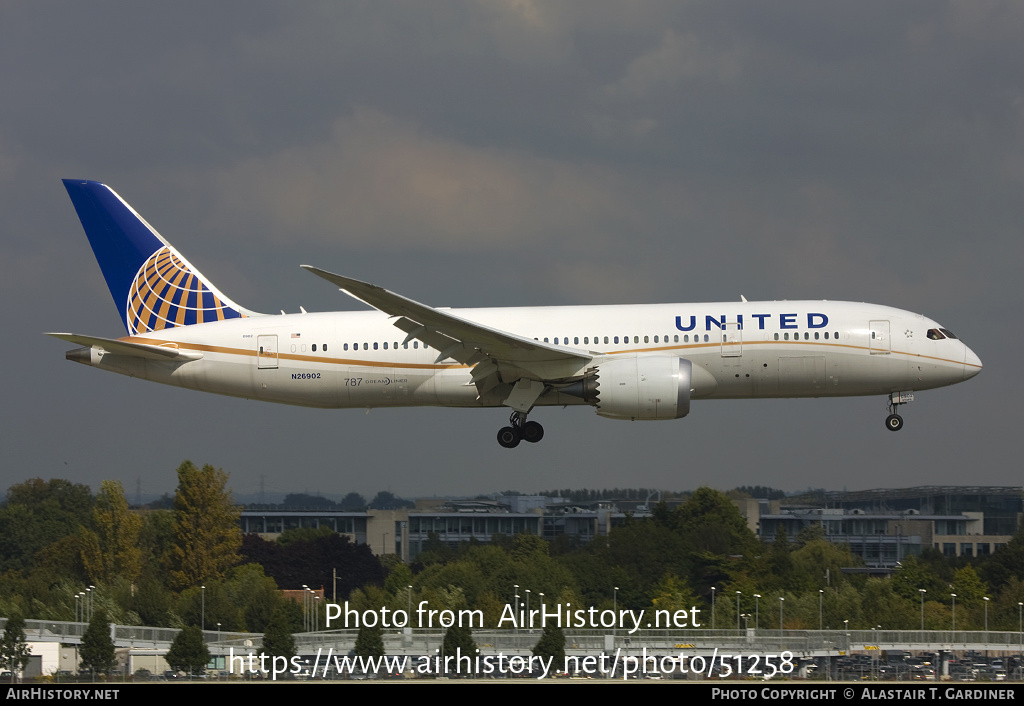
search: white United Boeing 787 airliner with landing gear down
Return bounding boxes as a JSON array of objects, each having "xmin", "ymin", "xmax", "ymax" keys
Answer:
[{"xmin": 50, "ymin": 179, "xmax": 981, "ymax": 448}]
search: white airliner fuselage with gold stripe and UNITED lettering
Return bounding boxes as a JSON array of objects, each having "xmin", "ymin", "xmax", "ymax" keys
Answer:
[{"xmin": 79, "ymin": 301, "xmax": 981, "ymax": 408}]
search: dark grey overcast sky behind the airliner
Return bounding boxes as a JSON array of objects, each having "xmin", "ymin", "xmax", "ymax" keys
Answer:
[{"xmin": 0, "ymin": 0, "xmax": 1024, "ymax": 498}]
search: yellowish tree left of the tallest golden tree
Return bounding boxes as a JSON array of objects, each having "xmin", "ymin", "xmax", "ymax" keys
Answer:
[{"xmin": 82, "ymin": 481, "xmax": 142, "ymax": 583}]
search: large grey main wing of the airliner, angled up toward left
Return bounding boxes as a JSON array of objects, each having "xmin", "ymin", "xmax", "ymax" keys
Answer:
[{"xmin": 302, "ymin": 264, "xmax": 593, "ymax": 394}]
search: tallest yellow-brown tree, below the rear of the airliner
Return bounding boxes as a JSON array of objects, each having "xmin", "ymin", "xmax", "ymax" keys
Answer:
[{"xmin": 170, "ymin": 461, "xmax": 242, "ymax": 588}]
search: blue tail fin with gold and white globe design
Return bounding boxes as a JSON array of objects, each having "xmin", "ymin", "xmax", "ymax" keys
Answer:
[{"xmin": 63, "ymin": 179, "xmax": 254, "ymax": 335}]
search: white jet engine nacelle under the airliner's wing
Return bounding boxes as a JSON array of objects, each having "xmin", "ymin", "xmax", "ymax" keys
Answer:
[{"xmin": 596, "ymin": 354, "xmax": 693, "ymax": 419}]
